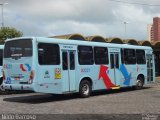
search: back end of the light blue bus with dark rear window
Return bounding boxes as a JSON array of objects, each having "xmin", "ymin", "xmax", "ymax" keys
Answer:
[{"xmin": 3, "ymin": 38, "xmax": 34, "ymax": 90}]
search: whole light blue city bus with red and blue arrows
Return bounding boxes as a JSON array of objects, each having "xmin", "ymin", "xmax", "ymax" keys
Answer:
[{"xmin": 3, "ymin": 37, "xmax": 155, "ymax": 97}]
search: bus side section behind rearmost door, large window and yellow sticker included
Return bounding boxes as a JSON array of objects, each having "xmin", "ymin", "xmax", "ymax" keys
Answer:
[{"xmin": 33, "ymin": 42, "xmax": 62, "ymax": 94}]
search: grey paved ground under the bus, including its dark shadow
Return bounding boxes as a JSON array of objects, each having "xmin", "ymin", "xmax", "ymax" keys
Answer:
[{"xmin": 0, "ymin": 83, "xmax": 160, "ymax": 119}]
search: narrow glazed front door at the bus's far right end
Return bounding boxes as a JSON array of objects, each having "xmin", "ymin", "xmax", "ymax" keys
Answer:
[{"xmin": 146, "ymin": 54, "xmax": 153, "ymax": 83}]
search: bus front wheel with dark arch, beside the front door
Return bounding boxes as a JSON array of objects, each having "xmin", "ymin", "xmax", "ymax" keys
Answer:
[{"xmin": 136, "ymin": 74, "xmax": 145, "ymax": 89}]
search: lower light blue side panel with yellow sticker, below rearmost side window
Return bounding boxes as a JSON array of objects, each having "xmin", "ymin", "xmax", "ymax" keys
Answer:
[{"xmin": 36, "ymin": 65, "xmax": 62, "ymax": 94}]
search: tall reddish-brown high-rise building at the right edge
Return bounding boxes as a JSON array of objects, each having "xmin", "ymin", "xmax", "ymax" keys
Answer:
[{"xmin": 147, "ymin": 17, "xmax": 160, "ymax": 42}]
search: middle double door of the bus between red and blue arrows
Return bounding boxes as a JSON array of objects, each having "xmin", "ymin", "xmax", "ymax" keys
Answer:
[{"xmin": 108, "ymin": 52, "xmax": 120, "ymax": 86}]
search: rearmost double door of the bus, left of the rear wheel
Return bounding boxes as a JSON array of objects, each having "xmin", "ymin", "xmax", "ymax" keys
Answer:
[{"xmin": 62, "ymin": 50, "xmax": 76, "ymax": 92}]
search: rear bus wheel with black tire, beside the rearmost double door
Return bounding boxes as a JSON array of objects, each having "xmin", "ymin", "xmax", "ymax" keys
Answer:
[{"xmin": 79, "ymin": 80, "xmax": 92, "ymax": 98}]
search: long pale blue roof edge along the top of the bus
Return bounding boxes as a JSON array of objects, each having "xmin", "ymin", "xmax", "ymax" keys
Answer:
[{"xmin": 5, "ymin": 37, "xmax": 152, "ymax": 50}]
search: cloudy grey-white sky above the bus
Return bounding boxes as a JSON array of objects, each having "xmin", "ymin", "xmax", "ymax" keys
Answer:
[{"xmin": 0, "ymin": 0, "xmax": 160, "ymax": 40}]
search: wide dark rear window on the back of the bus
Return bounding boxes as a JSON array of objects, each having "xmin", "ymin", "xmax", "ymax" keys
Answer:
[{"xmin": 4, "ymin": 39, "xmax": 32, "ymax": 58}]
